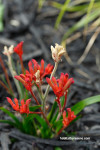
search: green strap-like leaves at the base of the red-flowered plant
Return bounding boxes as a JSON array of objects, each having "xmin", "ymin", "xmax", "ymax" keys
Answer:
[{"xmin": 0, "ymin": 95, "xmax": 100, "ymax": 138}]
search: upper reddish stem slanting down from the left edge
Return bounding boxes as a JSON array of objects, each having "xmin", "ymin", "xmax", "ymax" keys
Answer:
[{"xmin": 0, "ymin": 56, "xmax": 14, "ymax": 93}]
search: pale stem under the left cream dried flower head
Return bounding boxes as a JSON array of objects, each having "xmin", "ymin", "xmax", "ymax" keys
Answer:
[{"xmin": 8, "ymin": 54, "xmax": 22, "ymax": 98}]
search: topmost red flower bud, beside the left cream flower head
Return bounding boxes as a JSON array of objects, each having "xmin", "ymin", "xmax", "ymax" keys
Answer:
[{"xmin": 14, "ymin": 41, "xmax": 24, "ymax": 59}]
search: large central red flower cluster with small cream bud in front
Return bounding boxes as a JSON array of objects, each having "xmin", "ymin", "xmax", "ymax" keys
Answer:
[{"xmin": 15, "ymin": 59, "xmax": 53, "ymax": 91}]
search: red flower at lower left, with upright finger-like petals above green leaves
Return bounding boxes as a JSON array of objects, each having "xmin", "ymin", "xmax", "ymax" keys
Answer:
[{"xmin": 7, "ymin": 97, "xmax": 32, "ymax": 114}]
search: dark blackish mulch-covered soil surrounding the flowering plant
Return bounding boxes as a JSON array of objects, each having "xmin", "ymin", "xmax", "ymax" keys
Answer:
[{"xmin": 0, "ymin": 0, "xmax": 100, "ymax": 150}]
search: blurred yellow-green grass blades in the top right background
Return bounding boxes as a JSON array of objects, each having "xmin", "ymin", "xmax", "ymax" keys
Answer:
[{"xmin": 51, "ymin": 0, "xmax": 100, "ymax": 42}]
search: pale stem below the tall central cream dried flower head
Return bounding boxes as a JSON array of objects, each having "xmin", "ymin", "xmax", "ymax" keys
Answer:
[{"xmin": 43, "ymin": 62, "xmax": 58, "ymax": 112}]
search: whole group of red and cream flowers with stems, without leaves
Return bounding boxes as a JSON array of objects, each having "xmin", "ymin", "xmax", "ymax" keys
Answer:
[{"xmin": 0, "ymin": 41, "xmax": 76, "ymax": 137}]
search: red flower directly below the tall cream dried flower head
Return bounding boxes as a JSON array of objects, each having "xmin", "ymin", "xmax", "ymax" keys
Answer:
[{"xmin": 46, "ymin": 73, "xmax": 74, "ymax": 99}]
